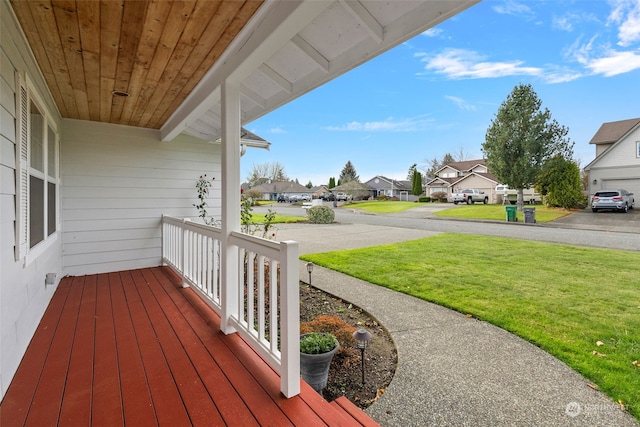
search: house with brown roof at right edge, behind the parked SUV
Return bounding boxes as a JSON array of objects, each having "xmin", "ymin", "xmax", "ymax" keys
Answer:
[{"xmin": 584, "ymin": 118, "xmax": 640, "ymax": 199}]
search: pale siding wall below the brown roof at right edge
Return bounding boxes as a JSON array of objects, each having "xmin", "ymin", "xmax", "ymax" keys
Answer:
[{"xmin": 589, "ymin": 128, "xmax": 640, "ymax": 199}]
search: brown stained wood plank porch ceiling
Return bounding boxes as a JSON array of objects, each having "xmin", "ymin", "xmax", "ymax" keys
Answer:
[{"xmin": 11, "ymin": 0, "xmax": 263, "ymax": 129}]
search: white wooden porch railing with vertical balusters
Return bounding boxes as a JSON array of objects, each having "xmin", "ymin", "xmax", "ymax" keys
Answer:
[{"xmin": 162, "ymin": 215, "xmax": 300, "ymax": 397}]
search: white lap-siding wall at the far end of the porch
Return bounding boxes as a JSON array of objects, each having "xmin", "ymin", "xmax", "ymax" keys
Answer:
[{"xmin": 60, "ymin": 120, "xmax": 221, "ymax": 275}]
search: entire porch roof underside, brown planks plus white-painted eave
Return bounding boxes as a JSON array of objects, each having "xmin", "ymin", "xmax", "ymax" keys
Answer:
[{"xmin": 10, "ymin": 0, "xmax": 479, "ymax": 141}]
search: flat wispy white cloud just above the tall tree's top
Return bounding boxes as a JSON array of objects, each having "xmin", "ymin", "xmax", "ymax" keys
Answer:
[{"xmin": 421, "ymin": 49, "xmax": 542, "ymax": 79}]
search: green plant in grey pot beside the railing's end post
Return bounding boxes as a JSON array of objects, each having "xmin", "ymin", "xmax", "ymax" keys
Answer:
[{"xmin": 300, "ymin": 332, "xmax": 340, "ymax": 393}]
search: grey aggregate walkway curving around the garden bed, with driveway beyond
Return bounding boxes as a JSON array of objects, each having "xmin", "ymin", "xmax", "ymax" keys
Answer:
[{"xmin": 278, "ymin": 224, "xmax": 638, "ymax": 427}]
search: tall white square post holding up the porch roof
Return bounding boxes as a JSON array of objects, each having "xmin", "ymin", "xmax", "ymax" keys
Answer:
[{"xmin": 220, "ymin": 79, "xmax": 241, "ymax": 334}]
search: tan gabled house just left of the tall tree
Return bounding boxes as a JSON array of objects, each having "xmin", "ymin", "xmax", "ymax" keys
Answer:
[{"xmin": 427, "ymin": 159, "xmax": 498, "ymax": 203}]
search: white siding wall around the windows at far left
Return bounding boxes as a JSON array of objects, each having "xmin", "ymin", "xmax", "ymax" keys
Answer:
[{"xmin": 0, "ymin": 1, "xmax": 62, "ymax": 398}]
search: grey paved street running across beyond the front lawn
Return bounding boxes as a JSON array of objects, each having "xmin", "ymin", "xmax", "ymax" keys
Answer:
[{"xmin": 254, "ymin": 203, "xmax": 640, "ymax": 253}]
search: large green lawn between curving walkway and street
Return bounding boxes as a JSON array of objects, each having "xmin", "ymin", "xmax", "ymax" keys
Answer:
[{"xmin": 301, "ymin": 234, "xmax": 640, "ymax": 420}]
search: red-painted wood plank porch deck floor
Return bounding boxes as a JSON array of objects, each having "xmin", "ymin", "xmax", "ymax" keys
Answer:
[{"xmin": 0, "ymin": 267, "xmax": 377, "ymax": 427}]
